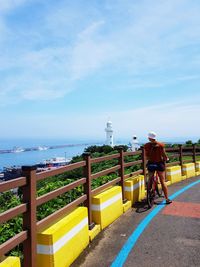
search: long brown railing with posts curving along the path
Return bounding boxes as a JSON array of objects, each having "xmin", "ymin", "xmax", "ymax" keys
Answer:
[{"xmin": 0, "ymin": 145, "xmax": 200, "ymax": 267}]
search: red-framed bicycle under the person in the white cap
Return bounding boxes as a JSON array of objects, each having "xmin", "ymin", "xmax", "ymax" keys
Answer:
[{"xmin": 147, "ymin": 172, "xmax": 162, "ymax": 209}]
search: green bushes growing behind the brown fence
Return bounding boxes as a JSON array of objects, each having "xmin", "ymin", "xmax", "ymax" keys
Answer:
[{"xmin": 0, "ymin": 142, "xmax": 200, "ymax": 262}]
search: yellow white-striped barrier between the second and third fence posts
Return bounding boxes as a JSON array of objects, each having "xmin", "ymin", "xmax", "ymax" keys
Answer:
[{"xmin": 92, "ymin": 186, "xmax": 123, "ymax": 229}]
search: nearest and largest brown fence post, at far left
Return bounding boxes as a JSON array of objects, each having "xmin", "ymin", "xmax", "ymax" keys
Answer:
[{"xmin": 22, "ymin": 166, "xmax": 37, "ymax": 267}]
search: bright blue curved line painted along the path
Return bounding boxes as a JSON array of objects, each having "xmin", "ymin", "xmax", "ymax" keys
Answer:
[{"xmin": 111, "ymin": 180, "xmax": 200, "ymax": 267}]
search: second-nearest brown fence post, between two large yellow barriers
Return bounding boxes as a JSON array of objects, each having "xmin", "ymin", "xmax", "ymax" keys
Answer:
[{"xmin": 83, "ymin": 152, "xmax": 95, "ymax": 230}]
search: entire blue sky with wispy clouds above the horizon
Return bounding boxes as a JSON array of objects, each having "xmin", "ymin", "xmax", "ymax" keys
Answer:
[{"xmin": 0, "ymin": 0, "xmax": 200, "ymax": 143}]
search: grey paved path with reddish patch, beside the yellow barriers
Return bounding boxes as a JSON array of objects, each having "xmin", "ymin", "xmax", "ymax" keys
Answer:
[{"xmin": 72, "ymin": 177, "xmax": 200, "ymax": 267}]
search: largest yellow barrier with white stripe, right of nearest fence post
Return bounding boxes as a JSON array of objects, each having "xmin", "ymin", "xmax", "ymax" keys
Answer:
[{"xmin": 37, "ymin": 207, "xmax": 89, "ymax": 267}]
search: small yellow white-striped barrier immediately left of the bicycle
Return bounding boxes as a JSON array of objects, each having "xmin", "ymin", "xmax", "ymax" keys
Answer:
[{"xmin": 125, "ymin": 175, "xmax": 145, "ymax": 204}]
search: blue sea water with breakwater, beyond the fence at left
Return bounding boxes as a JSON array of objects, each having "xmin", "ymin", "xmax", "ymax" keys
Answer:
[{"xmin": 0, "ymin": 139, "xmax": 101, "ymax": 169}]
